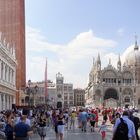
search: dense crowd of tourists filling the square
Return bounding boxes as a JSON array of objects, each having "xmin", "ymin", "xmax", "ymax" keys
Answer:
[{"xmin": 0, "ymin": 108, "xmax": 140, "ymax": 140}]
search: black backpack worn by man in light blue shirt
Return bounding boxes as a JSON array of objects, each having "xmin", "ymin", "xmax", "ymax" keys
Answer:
[{"xmin": 112, "ymin": 118, "xmax": 128, "ymax": 140}]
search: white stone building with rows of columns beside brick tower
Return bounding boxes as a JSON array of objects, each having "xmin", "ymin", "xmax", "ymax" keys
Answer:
[{"xmin": 0, "ymin": 33, "xmax": 17, "ymax": 110}]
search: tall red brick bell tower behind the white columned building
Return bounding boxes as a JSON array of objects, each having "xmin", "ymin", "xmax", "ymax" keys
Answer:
[{"xmin": 0, "ymin": 0, "xmax": 26, "ymax": 105}]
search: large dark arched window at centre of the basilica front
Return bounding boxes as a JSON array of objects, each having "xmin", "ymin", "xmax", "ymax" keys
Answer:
[{"xmin": 104, "ymin": 88, "xmax": 119, "ymax": 100}]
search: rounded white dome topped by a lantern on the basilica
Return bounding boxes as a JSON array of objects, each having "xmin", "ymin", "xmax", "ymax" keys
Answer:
[{"xmin": 124, "ymin": 41, "xmax": 140, "ymax": 66}]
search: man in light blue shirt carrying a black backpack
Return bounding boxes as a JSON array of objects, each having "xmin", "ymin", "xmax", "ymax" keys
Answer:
[{"xmin": 112, "ymin": 111, "xmax": 136, "ymax": 140}]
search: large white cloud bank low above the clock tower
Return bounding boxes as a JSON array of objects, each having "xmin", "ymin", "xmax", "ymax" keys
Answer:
[{"xmin": 26, "ymin": 27, "xmax": 116, "ymax": 88}]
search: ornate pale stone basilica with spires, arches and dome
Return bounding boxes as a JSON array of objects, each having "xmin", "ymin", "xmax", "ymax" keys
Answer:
[{"xmin": 85, "ymin": 41, "xmax": 140, "ymax": 108}]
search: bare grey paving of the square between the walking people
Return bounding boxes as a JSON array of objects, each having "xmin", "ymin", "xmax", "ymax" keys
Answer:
[{"xmin": 31, "ymin": 117, "xmax": 112, "ymax": 140}]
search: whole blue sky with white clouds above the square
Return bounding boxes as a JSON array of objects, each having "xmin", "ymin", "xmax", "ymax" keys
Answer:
[{"xmin": 25, "ymin": 0, "xmax": 140, "ymax": 88}]
